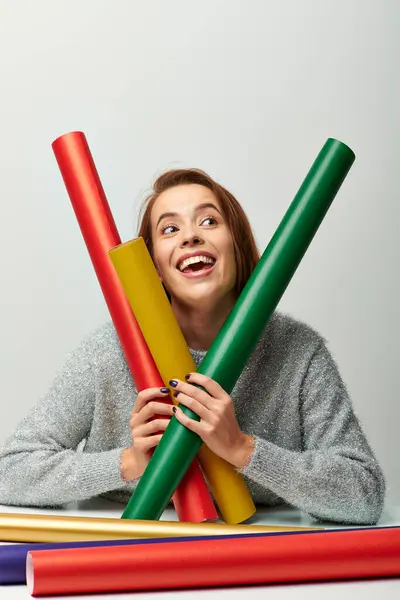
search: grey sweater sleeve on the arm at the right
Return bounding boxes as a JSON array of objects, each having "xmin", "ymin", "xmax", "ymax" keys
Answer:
[{"xmin": 241, "ymin": 342, "xmax": 385, "ymax": 524}]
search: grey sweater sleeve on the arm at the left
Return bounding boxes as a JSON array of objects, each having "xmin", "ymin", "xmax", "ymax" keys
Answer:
[{"xmin": 0, "ymin": 332, "xmax": 131, "ymax": 506}]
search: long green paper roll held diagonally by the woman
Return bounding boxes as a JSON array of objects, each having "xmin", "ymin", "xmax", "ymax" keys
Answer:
[{"xmin": 113, "ymin": 139, "xmax": 355, "ymax": 519}]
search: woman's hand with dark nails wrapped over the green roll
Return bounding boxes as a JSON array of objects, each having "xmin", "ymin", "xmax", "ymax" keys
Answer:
[{"xmin": 169, "ymin": 373, "xmax": 254, "ymax": 467}]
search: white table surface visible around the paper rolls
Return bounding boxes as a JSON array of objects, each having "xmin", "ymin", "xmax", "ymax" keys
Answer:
[{"xmin": 0, "ymin": 498, "xmax": 400, "ymax": 600}]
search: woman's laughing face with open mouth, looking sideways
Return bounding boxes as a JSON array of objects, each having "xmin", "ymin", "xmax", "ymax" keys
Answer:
[{"xmin": 151, "ymin": 184, "xmax": 236, "ymax": 310}]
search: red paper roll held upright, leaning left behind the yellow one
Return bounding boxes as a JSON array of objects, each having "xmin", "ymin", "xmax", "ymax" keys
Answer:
[{"xmin": 52, "ymin": 131, "xmax": 218, "ymax": 522}]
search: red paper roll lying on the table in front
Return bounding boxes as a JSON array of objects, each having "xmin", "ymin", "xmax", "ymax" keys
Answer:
[{"xmin": 26, "ymin": 528, "xmax": 400, "ymax": 596}]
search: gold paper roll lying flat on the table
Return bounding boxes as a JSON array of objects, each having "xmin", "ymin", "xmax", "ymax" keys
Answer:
[{"xmin": 0, "ymin": 513, "xmax": 315, "ymax": 543}]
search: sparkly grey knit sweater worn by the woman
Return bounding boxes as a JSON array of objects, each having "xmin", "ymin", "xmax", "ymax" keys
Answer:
[{"xmin": 0, "ymin": 312, "xmax": 385, "ymax": 524}]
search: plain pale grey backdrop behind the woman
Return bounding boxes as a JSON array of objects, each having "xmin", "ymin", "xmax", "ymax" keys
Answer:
[{"xmin": 0, "ymin": 0, "xmax": 400, "ymax": 502}]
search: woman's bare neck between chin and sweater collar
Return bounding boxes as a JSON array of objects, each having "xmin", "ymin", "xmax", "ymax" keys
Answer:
[{"xmin": 171, "ymin": 297, "xmax": 235, "ymax": 350}]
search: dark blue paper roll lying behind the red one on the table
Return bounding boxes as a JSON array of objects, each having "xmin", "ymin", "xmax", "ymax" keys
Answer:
[{"xmin": 0, "ymin": 532, "xmax": 276, "ymax": 585}]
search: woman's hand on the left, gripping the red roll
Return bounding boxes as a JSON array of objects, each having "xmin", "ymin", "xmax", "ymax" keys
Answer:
[{"xmin": 121, "ymin": 388, "xmax": 173, "ymax": 481}]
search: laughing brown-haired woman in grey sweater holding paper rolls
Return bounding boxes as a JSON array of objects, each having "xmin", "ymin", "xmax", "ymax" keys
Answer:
[{"xmin": 0, "ymin": 169, "xmax": 385, "ymax": 524}]
